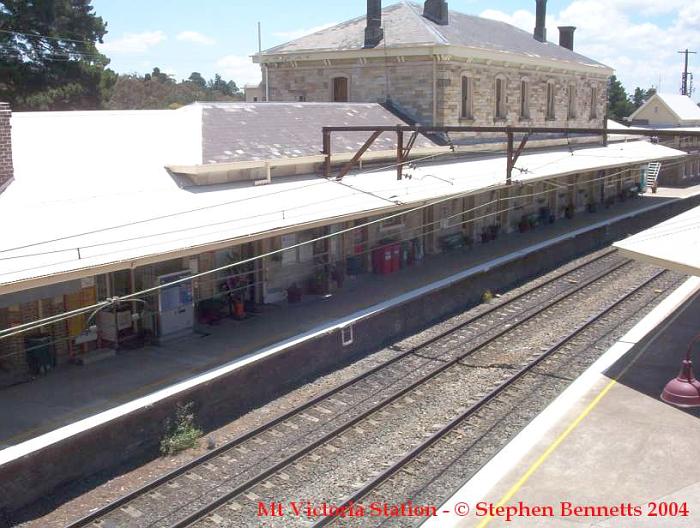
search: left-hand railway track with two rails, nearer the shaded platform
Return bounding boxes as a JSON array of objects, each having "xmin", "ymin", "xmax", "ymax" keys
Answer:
[{"xmin": 70, "ymin": 251, "xmax": 664, "ymax": 528}]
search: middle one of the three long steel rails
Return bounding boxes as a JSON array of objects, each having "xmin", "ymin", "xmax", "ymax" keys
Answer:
[{"xmin": 169, "ymin": 260, "xmax": 634, "ymax": 528}]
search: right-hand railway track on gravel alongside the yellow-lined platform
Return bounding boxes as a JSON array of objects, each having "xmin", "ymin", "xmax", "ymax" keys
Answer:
[{"xmin": 316, "ymin": 271, "xmax": 678, "ymax": 528}]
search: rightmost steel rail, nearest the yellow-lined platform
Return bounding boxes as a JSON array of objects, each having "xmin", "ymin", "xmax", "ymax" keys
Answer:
[{"xmin": 311, "ymin": 270, "xmax": 670, "ymax": 528}]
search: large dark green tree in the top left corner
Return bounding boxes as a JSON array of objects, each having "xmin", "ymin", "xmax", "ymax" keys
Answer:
[{"xmin": 0, "ymin": 0, "xmax": 116, "ymax": 110}]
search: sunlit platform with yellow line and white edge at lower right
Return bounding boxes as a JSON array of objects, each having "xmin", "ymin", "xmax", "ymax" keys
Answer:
[{"xmin": 423, "ymin": 268, "xmax": 700, "ymax": 528}]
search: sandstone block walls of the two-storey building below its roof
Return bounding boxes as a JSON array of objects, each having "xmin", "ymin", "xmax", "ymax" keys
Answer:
[{"xmin": 269, "ymin": 57, "xmax": 607, "ymax": 128}]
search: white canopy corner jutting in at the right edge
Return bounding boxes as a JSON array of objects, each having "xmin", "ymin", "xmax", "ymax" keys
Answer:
[{"xmin": 615, "ymin": 207, "xmax": 700, "ymax": 276}]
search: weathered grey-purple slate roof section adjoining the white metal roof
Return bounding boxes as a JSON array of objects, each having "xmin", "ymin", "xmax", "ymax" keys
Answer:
[{"xmin": 197, "ymin": 103, "xmax": 436, "ymax": 164}]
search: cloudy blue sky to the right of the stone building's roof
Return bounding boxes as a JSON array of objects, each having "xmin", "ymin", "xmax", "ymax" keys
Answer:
[{"xmin": 482, "ymin": 0, "xmax": 700, "ymax": 98}]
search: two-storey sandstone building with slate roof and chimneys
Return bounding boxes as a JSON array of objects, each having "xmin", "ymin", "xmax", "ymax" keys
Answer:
[{"xmin": 254, "ymin": 0, "xmax": 612, "ymax": 128}]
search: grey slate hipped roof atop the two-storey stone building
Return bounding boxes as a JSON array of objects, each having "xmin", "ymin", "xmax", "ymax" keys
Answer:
[{"xmin": 262, "ymin": 1, "xmax": 608, "ymax": 69}]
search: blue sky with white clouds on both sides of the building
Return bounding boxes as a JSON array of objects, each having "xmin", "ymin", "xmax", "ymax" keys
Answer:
[{"xmin": 93, "ymin": 0, "xmax": 700, "ymax": 101}]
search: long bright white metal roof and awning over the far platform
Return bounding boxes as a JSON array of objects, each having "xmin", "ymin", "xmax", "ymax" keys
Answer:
[{"xmin": 0, "ymin": 108, "xmax": 685, "ymax": 291}]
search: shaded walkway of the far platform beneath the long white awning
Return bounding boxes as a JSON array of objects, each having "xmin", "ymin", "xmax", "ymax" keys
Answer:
[{"xmin": 0, "ymin": 188, "xmax": 700, "ymax": 449}]
